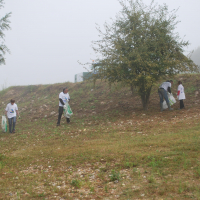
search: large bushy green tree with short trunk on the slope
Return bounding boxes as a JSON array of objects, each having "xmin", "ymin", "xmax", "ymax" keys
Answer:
[{"xmin": 93, "ymin": 0, "xmax": 197, "ymax": 110}]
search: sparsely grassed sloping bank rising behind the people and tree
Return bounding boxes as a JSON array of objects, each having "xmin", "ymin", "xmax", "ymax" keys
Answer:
[{"xmin": 0, "ymin": 75, "xmax": 200, "ymax": 121}]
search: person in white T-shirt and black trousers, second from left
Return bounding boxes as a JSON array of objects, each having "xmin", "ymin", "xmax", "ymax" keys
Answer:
[{"xmin": 57, "ymin": 88, "xmax": 70, "ymax": 126}]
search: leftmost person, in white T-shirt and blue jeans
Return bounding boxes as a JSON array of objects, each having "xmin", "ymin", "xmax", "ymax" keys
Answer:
[{"xmin": 5, "ymin": 99, "xmax": 20, "ymax": 133}]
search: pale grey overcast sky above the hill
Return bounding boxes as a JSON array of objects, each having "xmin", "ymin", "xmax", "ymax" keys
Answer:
[{"xmin": 0, "ymin": 0, "xmax": 200, "ymax": 88}]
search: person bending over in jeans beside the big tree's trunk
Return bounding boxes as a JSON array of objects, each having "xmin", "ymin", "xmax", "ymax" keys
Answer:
[{"xmin": 158, "ymin": 80, "xmax": 173, "ymax": 112}]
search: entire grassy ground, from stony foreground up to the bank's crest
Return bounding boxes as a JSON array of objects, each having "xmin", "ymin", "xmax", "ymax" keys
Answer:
[{"xmin": 0, "ymin": 75, "xmax": 200, "ymax": 200}]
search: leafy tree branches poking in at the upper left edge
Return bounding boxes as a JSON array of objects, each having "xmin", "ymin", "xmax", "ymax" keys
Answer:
[{"xmin": 0, "ymin": 0, "xmax": 11, "ymax": 65}]
